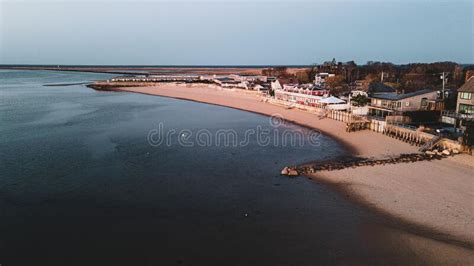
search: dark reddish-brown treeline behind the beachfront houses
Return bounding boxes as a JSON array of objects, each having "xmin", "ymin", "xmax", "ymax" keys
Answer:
[{"xmin": 263, "ymin": 59, "xmax": 474, "ymax": 92}]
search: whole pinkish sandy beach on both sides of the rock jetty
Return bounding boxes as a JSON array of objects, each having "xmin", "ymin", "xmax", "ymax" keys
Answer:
[{"xmin": 108, "ymin": 84, "xmax": 474, "ymax": 254}]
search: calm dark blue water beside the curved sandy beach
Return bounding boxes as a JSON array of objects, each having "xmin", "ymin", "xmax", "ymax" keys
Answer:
[{"xmin": 0, "ymin": 71, "xmax": 420, "ymax": 265}]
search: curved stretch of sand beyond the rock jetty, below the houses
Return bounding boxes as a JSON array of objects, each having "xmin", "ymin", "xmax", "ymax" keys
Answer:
[{"xmin": 99, "ymin": 84, "xmax": 417, "ymax": 157}]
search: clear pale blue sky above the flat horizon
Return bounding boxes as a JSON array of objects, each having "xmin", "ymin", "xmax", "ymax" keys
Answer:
[{"xmin": 0, "ymin": 0, "xmax": 474, "ymax": 65}]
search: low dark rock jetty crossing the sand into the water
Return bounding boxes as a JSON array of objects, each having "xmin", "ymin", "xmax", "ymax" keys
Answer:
[{"xmin": 281, "ymin": 150, "xmax": 458, "ymax": 177}]
